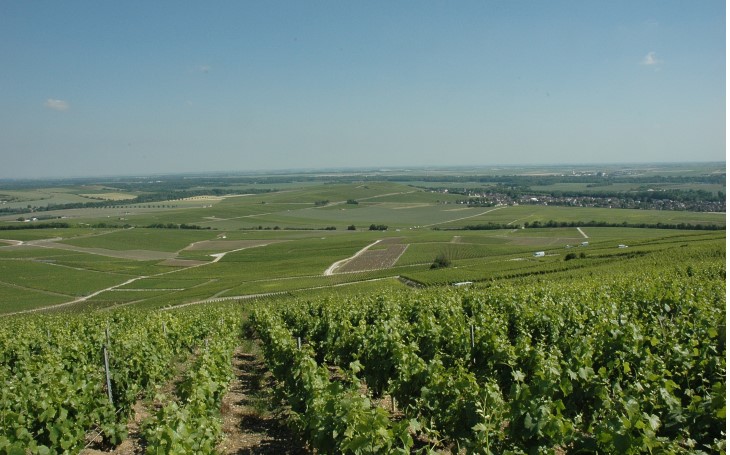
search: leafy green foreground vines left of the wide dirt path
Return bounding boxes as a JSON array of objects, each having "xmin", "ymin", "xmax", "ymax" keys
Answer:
[{"xmin": 0, "ymin": 307, "xmax": 241, "ymax": 454}]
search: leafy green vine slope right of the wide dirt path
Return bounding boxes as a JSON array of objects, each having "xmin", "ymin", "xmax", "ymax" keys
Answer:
[{"xmin": 246, "ymin": 244, "xmax": 726, "ymax": 453}]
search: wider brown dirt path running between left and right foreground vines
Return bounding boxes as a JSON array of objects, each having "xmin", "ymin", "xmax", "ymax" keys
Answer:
[{"xmin": 217, "ymin": 346, "xmax": 309, "ymax": 455}]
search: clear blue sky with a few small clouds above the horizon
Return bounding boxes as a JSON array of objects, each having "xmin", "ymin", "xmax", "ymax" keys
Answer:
[{"xmin": 0, "ymin": 0, "xmax": 726, "ymax": 178}]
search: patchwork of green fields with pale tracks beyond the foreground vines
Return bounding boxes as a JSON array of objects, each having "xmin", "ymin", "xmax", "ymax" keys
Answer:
[{"xmin": 0, "ymin": 173, "xmax": 725, "ymax": 313}]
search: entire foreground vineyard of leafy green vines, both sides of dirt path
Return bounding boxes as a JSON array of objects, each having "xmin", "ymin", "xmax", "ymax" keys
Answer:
[{"xmin": 0, "ymin": 242, "xmax": 726, "ymax": 454}]
